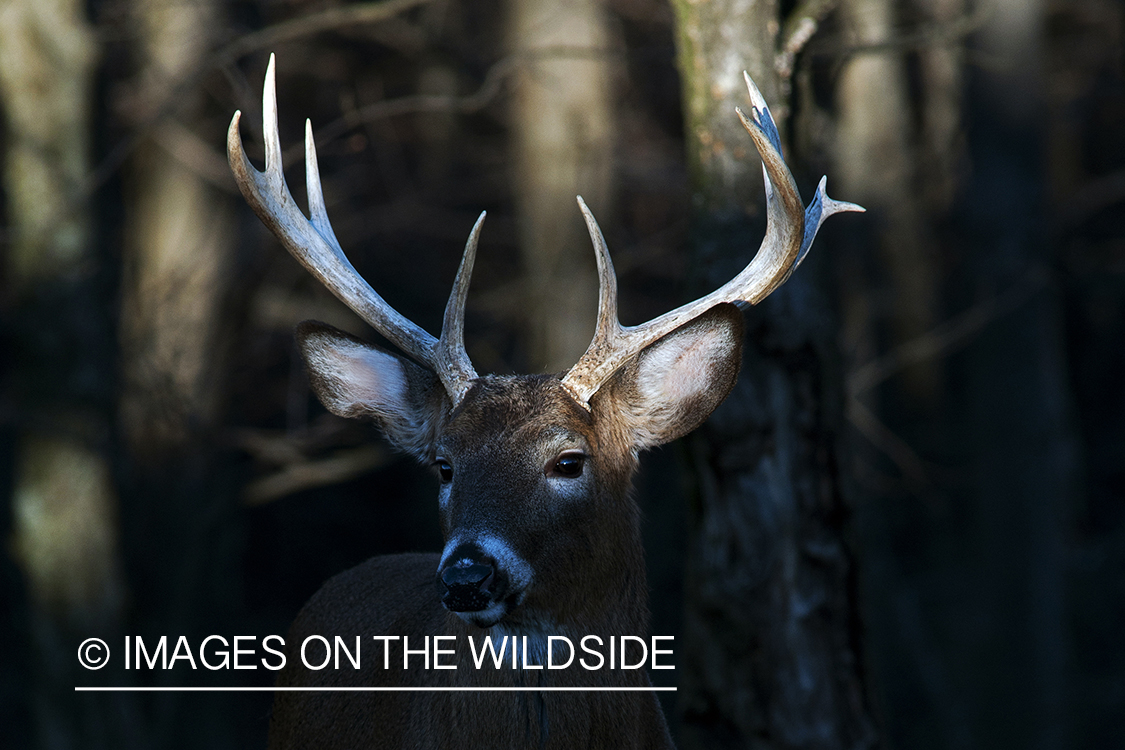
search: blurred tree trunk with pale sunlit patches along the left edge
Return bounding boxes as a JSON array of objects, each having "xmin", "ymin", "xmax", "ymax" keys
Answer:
[{"xmin": 0, "ymin": 0, "xmax": 125, "ymax": 748}]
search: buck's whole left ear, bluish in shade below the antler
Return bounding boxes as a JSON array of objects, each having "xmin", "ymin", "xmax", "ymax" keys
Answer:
[{"xmin": 296, "ymin": 320, "xmax": 449, "ymax": 460}]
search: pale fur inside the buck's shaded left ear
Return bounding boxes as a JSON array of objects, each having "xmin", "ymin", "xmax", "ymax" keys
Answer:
[{"xmin": 306, "ymin": 336, "xmax": 408, "ymax": 418}]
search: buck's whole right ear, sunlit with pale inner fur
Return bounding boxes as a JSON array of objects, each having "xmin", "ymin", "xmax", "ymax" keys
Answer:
[{"xmin": 612, "ymin": 304, "xmax": 743, "ymax": 450}]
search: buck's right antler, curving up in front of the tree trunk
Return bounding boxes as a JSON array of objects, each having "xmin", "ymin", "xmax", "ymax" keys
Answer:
[{"xmin": 563, "ymin": 73, "xmax": 864, "ymax": 406}]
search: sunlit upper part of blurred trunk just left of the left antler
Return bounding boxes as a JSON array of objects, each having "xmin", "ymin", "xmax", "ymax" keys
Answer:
[{"xmin": 120, "ymin": 0, "xmax": 234, "ymax": 460}]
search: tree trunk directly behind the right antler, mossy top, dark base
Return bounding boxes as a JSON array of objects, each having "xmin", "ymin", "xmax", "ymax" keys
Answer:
[{"xmin": 675, "ymin": 1, "xmax": 875, "ymax": 748}]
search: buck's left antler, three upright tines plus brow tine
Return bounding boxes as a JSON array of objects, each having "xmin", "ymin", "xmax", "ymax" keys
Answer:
[{"xmin": 226, "ymin": 55, "xmax": 485, "ymax": 405}]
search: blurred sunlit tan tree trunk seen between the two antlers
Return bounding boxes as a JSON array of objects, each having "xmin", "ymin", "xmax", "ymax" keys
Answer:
[{"xmin": 509, "ymin": 0, "xmax": 613, "ymax": 371}]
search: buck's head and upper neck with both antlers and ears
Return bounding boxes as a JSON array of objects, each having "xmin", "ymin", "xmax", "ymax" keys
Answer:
[{"xmin": 227, "ymin": 56, "xmax": 863, "ymax": 633}]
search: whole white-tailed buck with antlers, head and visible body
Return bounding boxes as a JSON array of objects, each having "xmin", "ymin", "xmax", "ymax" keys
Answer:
[{"xmin": 227, "ymin": 57, "xmax": 862, "ymax": 750}]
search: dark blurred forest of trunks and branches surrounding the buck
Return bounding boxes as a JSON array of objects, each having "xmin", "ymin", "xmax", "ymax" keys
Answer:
[{"xmin": 0, "ymin": 0, "xmax": 1125, "ymax": 750}]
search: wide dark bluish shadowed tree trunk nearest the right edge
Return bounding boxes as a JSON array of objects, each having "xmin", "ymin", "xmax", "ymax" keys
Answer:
[{"xmin": 960, "ymin": 0, "xmax": 1081, "ymax": 750}]
